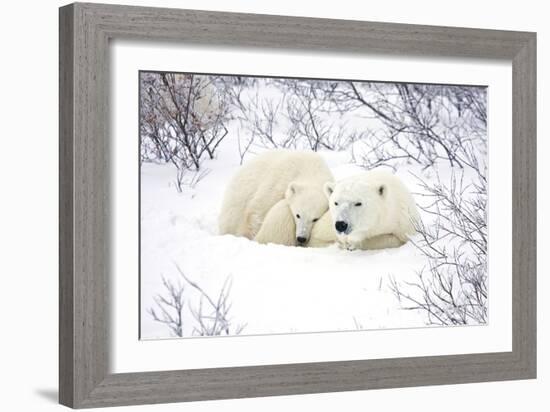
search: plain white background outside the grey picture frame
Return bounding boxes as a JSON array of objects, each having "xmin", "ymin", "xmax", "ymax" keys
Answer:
[{"xmin": 0, "ymin": 0, "xmax": 550, "ymax": 412}]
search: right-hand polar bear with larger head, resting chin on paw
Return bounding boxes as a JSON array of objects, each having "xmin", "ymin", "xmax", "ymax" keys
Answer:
[{"xmin": 324, "ymin": 170, "xmax": 420, "ymax": 250}]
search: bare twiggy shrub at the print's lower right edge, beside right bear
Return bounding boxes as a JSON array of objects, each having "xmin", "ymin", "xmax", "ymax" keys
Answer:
[{"xmin": 390, "ymin": 174, "xmax": 488, "ymax": 325}]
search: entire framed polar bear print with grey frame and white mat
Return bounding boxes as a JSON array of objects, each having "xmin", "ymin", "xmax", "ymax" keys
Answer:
[{"xmin": 60, "ymin": 3, "xmax": 536, "ymax": 408}]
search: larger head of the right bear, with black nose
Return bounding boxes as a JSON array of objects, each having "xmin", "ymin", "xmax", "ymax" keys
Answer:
[{"xmin": 324, "ymin": 178, "xmax": 388, "ymax": 237}]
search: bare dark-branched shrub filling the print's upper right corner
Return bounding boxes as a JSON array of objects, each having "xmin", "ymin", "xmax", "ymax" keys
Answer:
[{"xmin": 324, "ymin": 81, "xmax": 487, "ymax": 168}]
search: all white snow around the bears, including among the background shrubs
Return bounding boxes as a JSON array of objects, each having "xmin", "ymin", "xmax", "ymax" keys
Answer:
[{"xmin": 140, "ymin": 79, "xmax": 492, "ymax": 339}]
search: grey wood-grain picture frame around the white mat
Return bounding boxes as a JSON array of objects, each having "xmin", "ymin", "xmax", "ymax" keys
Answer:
[{"xmin": 59, "ymin": 3, "xmax": 536, "ymax": 408}]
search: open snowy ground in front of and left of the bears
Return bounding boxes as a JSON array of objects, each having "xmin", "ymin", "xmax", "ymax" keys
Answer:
[{"xmin": 141, "ymin": 139, "xmax": 434, "ymax": 339}]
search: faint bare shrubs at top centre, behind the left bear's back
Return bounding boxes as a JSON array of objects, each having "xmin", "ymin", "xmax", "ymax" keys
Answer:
[{"xmin": 225, "ymin": 79, "xmax": 365, "ymax": 157}]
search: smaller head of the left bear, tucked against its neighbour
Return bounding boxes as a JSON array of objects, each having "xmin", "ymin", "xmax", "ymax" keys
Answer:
[{"xmin": 285, "ymin": 181, "xmax": 328, "ymax": 246}]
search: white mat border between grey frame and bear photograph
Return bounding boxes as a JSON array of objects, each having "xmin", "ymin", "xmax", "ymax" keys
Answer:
[{"xmin": 110, "ymin": 41, "xmax": 512, "ymax": 373}]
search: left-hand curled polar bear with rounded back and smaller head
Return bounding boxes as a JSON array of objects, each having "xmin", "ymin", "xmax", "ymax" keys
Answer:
[{"xmin": 219, "ymin": 150, "xmax": 333, "ymax": 246}]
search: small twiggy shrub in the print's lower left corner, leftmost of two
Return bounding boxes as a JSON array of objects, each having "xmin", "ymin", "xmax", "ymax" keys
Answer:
[{"xmin": 148, "ymin": 277, "xmax": 185, "ymax": 337}]
